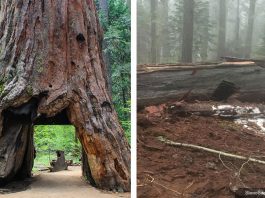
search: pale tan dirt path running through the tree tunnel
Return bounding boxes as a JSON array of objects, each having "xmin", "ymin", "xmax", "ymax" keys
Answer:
[{"xmin": 0, "ymin": 167, "xmax": 130, "ymax": 198}]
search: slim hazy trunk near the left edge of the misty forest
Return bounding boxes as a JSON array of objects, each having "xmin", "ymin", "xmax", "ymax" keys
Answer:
[{"xmin": 151, "ymin": 0, "xmax": 157, "ymax": 63}]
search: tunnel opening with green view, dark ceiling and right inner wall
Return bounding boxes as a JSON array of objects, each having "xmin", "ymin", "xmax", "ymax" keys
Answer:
[{"xmin": 33, "ymin": 109, "xmax": 96, "ymax": 187}]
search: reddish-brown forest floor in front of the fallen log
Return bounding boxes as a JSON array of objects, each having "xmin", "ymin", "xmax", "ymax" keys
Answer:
[{"xmin": 137, "ymin": 101, "xmax": 265, "ymax": 198}]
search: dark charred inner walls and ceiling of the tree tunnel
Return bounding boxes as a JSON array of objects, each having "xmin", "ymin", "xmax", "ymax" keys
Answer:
[{"xmin": 0, "ymin": 97, "xmax": 126, "ymax": 190}]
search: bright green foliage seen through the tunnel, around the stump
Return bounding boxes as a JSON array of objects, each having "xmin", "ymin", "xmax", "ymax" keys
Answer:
[{"xmin": 34, "ymin": 125, "xmax": 81, "ymax": 165}]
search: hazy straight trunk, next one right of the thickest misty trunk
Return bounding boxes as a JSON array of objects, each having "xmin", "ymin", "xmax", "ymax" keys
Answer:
[{"xmin": 217, "ymin": 0, "xmax": 226, "ymax": 59}]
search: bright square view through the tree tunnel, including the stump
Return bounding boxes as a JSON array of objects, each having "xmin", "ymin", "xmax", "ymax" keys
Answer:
[{"xmin": 33, "ymin": 124, "xmax": 81, "ymax": 173}]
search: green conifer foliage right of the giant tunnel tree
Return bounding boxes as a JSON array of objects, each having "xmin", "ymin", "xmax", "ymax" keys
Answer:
[{"xmin": 98, "ymin": 0, "xmax": 131, "ymax": 142}]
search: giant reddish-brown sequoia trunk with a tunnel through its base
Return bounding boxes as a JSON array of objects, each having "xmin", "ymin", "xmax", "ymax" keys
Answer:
[{"xmin": 0, "ymin": 0, "xmax": 130, "ymax": 191}]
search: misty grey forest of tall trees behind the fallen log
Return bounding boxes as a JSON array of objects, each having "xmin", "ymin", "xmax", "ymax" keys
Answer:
[{"xmin": 137, "ymin": 0, "xmax": 265, "ymax": 64}]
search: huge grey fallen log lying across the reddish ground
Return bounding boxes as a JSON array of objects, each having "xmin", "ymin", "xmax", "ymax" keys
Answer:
[{"xmin": 137, "ymin": 62, "xmax": 265, "ymax": 107}]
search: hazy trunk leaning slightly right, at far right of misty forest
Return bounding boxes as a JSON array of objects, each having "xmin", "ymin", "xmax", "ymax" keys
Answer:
[{"xmin": 245, "ymin": 0, "xmax": 256, "ymax": 58}]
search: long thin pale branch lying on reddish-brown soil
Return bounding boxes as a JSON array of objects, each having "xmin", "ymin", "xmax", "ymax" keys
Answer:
[{"xmin": 158, "ymin": 136, "xmax": 265, "ymax": 164}]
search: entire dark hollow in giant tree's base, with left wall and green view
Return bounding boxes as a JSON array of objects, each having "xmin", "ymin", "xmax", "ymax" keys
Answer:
[{"xmin": 0, "ymin": 103, "xmax": 96, "ymax": 186}]
